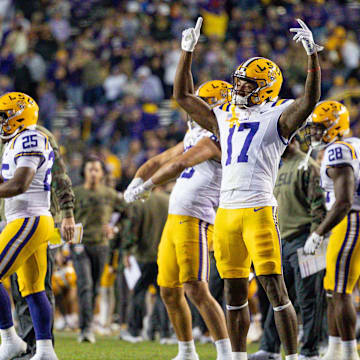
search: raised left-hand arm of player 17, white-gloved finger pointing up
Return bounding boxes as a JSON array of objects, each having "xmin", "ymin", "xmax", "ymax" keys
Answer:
[{"xmin": 174, "ymin": 18, "xmax": 218, "ymax": 135}]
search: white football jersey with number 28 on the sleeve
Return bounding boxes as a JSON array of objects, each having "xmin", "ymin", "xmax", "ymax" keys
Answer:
[{"xmin": 320, "ymin": 137, "xmax": 360, "ymax": 211}]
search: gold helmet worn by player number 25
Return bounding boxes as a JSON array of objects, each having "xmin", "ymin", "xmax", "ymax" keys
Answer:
[{"xmin": 0, "ymin": 92, "xmax": 39, "ymax": 140}]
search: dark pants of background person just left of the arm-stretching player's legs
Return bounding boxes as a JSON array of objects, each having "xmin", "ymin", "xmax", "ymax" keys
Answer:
[{"xmin": 128, "ymin": 262, "xmax": 169, "ymax": 337}]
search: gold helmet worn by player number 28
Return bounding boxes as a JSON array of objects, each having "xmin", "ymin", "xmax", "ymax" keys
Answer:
[{"xmin": 308, "ymin": 100, "xmax": 350, "ymax": 146}]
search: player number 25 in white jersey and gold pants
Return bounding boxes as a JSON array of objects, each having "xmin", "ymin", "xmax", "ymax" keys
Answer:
[{"xmin": 0, "ymin": 92, "xmax": 57, "ymax": 360}]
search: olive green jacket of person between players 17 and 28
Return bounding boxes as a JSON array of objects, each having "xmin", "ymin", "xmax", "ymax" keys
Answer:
[{"xmin": 274, "ymin": 151, "xmax": 326, "ymax": 241}]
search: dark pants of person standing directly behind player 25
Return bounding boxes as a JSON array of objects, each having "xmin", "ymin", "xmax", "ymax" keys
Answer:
[{"xmin": 10, "ymin": 248, "xmax": 56, "ymax": 354}]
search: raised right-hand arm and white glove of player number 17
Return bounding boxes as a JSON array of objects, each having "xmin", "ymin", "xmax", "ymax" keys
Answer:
[{"xmin": 279, "ymin": 19, "xmax": 321, "ymax": 139}]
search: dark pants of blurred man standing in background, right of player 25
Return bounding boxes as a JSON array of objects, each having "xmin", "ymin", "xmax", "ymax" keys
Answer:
[{"xmin": 71, "ymin": 244, "xmax": 108, "ymax": 332}]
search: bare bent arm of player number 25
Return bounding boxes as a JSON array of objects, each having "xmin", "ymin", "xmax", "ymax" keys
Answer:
[{"xmin": 0, "ymin": 167, "xmax": 35, "ymax": 198}]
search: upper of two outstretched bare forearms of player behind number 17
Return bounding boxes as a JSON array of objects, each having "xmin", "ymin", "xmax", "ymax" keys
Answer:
[{"xmin": 135, "ymin": 141, "xmax": 184, "ymax": 181}]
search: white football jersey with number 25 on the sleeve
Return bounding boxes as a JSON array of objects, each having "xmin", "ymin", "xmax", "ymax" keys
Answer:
[{"xmin": 1, "ymin": 129, "xmax": 54, "ymax": 222}]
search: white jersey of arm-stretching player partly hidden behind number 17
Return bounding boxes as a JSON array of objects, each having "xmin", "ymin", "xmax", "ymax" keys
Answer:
[{"xmin": 169, "ymin": 123, "xmax": 221, "ymax": 224}]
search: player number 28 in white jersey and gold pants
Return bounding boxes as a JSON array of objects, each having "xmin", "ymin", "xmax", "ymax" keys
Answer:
[{"xmin": 304, "ymin": 101, "xmax": 360, "ymax": 360}]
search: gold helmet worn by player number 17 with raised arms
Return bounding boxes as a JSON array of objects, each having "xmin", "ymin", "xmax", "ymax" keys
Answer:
[{"xmin": 232, "ymin": 57, "xmax": 283, "ymax": 106}]
